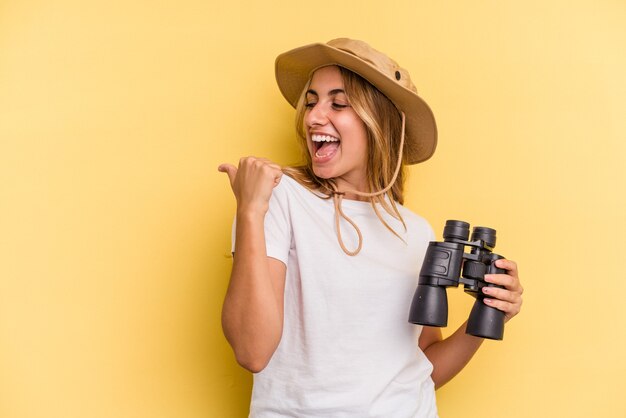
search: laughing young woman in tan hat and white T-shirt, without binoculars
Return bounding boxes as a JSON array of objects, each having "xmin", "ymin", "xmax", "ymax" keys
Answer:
[{"xmin": 219, "ymin": 38, "xmax": 522, "ymax": 418}]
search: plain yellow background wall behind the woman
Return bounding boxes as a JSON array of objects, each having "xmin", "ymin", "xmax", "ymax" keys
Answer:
[{"xmin": 0, "ymin": 0, "xmax": 626, "ymax": 418}]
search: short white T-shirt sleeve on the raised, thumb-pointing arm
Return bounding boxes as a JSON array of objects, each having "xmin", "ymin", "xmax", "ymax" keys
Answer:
[{"xmin": 231, "ymin": 176, "xmax": 292, "ymax": 265}]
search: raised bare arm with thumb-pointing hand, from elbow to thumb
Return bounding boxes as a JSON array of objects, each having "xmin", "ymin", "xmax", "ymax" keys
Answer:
[{"xmin": 219, "ymin": 157, "xmax": 286, "ymax": 373}]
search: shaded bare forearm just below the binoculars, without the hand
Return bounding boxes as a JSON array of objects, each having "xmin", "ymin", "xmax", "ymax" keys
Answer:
[{"xmin": 424, "ymin": 322, "xmax": 483, "ymax": 388}]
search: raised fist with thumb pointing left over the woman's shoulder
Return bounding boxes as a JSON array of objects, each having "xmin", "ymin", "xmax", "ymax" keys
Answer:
[{"xmin": 217, "ymin": 157, "xmax": 283, "ymax": 215}]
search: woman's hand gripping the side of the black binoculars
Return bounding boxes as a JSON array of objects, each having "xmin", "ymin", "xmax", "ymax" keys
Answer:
[{"xmin": 483, "ymin": 259, "xmax": 524, "ymax": 322}]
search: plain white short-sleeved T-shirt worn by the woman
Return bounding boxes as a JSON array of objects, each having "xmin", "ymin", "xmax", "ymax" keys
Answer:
[{"xmin": 233, "ymin": 176, "xmax": 437, "ymax": 418}]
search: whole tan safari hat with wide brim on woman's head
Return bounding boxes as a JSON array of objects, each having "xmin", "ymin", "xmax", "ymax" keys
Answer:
[{"xmin": 276, "ymin": 38, "xmax": 437, "ymax": 164}]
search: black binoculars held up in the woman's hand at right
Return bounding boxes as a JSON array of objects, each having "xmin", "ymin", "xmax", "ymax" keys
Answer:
[{"xmin": 409, "ymin": 220, "xmax": 506, "ymax": 340}]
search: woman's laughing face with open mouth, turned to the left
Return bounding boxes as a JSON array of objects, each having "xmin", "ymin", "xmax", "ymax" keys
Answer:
[{"xmin": 304, "ymin": 66, "xmax": 367, "ymax": 190}]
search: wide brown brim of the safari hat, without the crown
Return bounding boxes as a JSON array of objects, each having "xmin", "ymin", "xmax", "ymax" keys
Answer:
[{"xmin": 275, "ymin": 43, "xmax": 437, "ymax": 164}]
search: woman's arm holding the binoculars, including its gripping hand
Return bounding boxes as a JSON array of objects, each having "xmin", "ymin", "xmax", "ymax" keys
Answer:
[{"xmin": 419, "ymin": 260, "xmax": 524, "ymax": 389}]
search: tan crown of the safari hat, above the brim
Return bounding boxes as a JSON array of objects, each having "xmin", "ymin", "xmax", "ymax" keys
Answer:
[{"xmin": 327, "ymin": 38, "xmax": 417, "ymax": 93}]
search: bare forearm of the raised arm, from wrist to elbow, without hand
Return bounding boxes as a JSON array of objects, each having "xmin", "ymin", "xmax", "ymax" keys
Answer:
[{"xmin": 222, "ymin": 212, "xmax": 283, "ymax": 372}]
